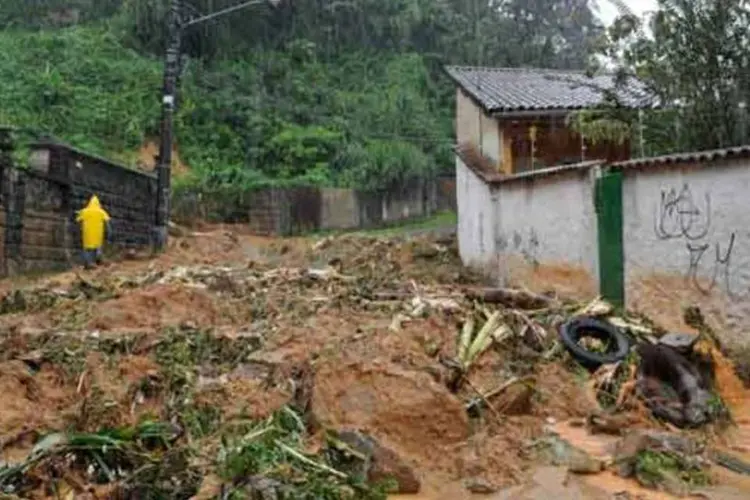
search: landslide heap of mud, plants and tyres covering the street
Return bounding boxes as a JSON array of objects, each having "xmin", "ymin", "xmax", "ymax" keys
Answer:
[{"xmin": 0, "ymin": 229, "xmax": 750, "ymax": 499}]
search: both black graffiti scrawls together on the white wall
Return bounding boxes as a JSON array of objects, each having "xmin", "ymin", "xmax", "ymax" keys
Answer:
[{"xmin": 654, "ymin": 183, "xmax": 738, "ymax": 297}]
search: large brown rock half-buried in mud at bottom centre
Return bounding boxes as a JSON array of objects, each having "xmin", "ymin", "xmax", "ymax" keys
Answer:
[{"xmin": 328, "ymin": 430, "xmax": 421, "ymax": 494}]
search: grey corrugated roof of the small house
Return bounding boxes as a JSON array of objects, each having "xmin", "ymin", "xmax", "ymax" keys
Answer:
[{"xmin": 445, "ymin": 66, "xmax": 655, "ymax": 113}]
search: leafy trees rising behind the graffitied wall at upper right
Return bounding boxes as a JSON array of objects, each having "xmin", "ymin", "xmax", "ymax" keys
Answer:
[{"xmin": 589, "ymin": 0, "xmax": 750, "ymax": 154}]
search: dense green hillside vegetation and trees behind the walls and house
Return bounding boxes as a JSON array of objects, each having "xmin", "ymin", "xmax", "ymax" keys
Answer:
[{"xmin": 0, "ymin": 0, "xmax": 750, "ymax": 188}]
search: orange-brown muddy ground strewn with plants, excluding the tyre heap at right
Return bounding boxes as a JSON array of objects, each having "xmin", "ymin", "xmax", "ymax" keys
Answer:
[{"xmin": 0, "ymin": 227, "xmax": 750, "ymax": 500}]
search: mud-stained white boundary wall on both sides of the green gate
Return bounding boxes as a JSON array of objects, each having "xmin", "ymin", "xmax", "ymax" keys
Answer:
[{"xmin": 456, "ymin": 148, "xmax": 750, "ymax": 347}]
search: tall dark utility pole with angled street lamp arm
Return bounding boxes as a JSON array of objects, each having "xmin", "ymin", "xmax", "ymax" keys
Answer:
[{"xmin": 154, "ymin": 0, "xmax": 281, "ymax": 250}]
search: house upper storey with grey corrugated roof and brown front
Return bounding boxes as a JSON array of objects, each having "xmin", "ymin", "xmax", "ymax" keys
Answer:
[{"xmin": 446, "ymin": 66, "xmax": 652, "ymax": 175}]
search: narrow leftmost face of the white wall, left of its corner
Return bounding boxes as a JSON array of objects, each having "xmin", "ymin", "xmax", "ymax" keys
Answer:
[{"xmin": 456, "ymin": 158, "xmax": 497, "ymax": 267}]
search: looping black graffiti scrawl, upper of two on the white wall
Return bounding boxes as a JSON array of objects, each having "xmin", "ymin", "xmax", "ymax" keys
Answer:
[{"xmin": 654, "ymin": 184, "xmax": 711, "ymax": 241}]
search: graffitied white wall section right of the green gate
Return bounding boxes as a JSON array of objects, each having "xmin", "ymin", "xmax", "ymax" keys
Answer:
[{"xmin": 623, "ymin": 160, "xmax": 750, "ymax": 342}]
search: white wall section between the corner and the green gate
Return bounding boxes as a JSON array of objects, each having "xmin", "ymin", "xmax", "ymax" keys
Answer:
[{"xmin": 497, "ymin": 169, "xmax": 598, "ymax": 282}]
